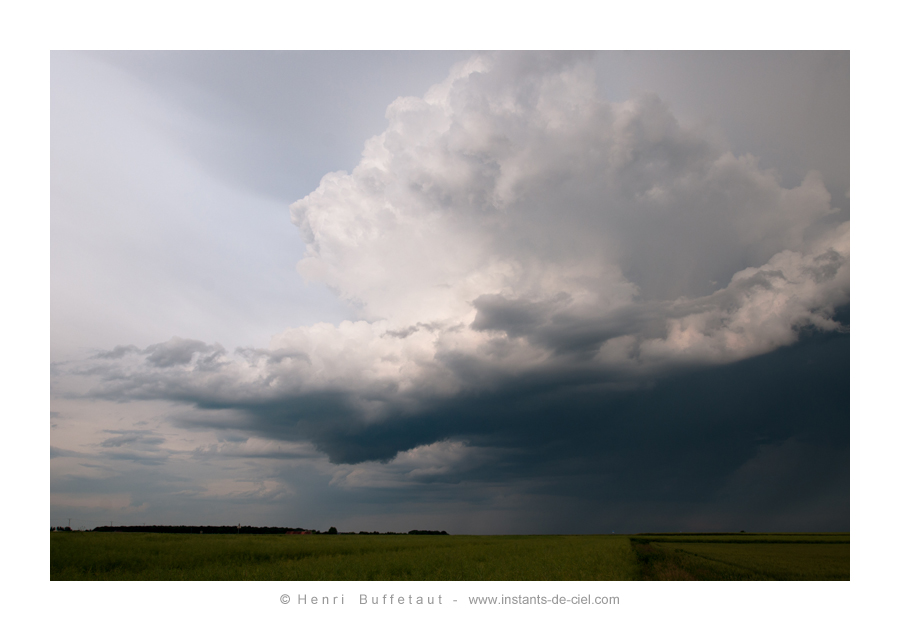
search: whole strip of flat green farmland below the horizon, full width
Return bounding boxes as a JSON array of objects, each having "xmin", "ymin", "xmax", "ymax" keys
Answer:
[{"xmin": 50, "ymin": 532, "xmax": 850, "ymax": 581}]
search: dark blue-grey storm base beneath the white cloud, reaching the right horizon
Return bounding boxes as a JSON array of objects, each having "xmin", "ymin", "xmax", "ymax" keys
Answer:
[{"xmin": 179, "ymin": 307, "xmax": 850, "ymax": 532}]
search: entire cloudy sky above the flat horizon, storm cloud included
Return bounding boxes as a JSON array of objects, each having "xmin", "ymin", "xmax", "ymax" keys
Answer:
[{"xmin": 50, "ymin": 52, "xmax": 850, "ymax": 534}]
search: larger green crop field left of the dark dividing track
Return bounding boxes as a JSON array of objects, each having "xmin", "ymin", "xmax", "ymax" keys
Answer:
[{"xmin": 50, "ymin": 532, "xmax": 640, "ymax": 581}]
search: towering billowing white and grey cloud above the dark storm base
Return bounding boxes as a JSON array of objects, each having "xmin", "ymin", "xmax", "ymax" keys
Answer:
[{"xmin": 74, "ymin": 55, "xmax": 850, "ymax": 460}]
